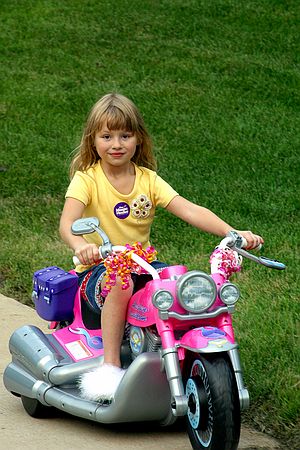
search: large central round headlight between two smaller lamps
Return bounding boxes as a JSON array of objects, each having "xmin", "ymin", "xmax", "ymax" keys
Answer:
[{"xmin": 177, "ymin": 270, "xmax": 217, "ymax": 313}]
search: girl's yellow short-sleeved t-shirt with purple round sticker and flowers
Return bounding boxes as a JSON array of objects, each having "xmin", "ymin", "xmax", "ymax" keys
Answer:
[{"xmin": 66, "ymin": 161, "xmax": 178, "ymax": 271}]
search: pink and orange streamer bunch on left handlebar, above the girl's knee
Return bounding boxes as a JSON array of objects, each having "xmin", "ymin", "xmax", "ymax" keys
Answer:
[{"xmin": 101, "ymin": 242, "xmax": 157, "ymax": 297}]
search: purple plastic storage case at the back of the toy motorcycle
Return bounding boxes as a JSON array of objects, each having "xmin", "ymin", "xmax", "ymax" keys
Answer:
[{"xmin": 32, "ymin": 266, "xmax": 78, "ymax": 321}]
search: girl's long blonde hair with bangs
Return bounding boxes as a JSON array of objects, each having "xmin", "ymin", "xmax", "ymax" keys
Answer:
[{"xmin": 70, "ymin": 93, "xmax": 156, "ymax": 178}]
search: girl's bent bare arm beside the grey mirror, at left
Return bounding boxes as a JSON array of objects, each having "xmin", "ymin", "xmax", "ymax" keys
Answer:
[{"xmin": 59, "ymin": 197, "xmax": 99, "ymax": 265}]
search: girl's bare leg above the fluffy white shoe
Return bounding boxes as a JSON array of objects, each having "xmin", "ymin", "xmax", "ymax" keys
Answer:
[{"xmin": 101, "ymin": 280, "xmax": 133, "ymax": 367}]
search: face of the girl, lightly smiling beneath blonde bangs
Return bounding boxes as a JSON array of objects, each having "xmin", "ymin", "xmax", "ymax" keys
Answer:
[{"xmin": 94, "ymin": 124, "xmax": 138, "ymax": 167}]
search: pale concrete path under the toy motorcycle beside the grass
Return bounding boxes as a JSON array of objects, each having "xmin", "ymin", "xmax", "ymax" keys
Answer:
[{"xmin": 0, "ymin": 294, "xmax": 280, "ymax": 450}]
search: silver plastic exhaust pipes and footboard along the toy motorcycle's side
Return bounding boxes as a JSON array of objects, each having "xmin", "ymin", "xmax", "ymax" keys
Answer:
[{"xmin": 3, "ymin": 326, "xmax": 171, "ymax": 423}]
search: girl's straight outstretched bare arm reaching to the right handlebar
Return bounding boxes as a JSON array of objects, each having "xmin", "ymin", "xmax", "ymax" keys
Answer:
[{"xmin": 166, "ymin": 195, "xmax": 263, "ymax": 249}]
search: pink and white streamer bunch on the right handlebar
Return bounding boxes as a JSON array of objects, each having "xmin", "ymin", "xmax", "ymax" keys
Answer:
[{"xmin": 209, "ymin": 247, "xmax": 242, "ymax": 279}]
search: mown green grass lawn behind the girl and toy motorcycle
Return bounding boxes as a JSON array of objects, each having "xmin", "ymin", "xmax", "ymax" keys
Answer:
[{"xmin": 0, "ymin": 0, "xmax": 300, "ymax": 448}]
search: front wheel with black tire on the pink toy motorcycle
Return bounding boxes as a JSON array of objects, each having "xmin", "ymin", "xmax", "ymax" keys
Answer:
[{"xmin": 185, "ymin": 354, "xmax": 241, "ymax": 450}]
